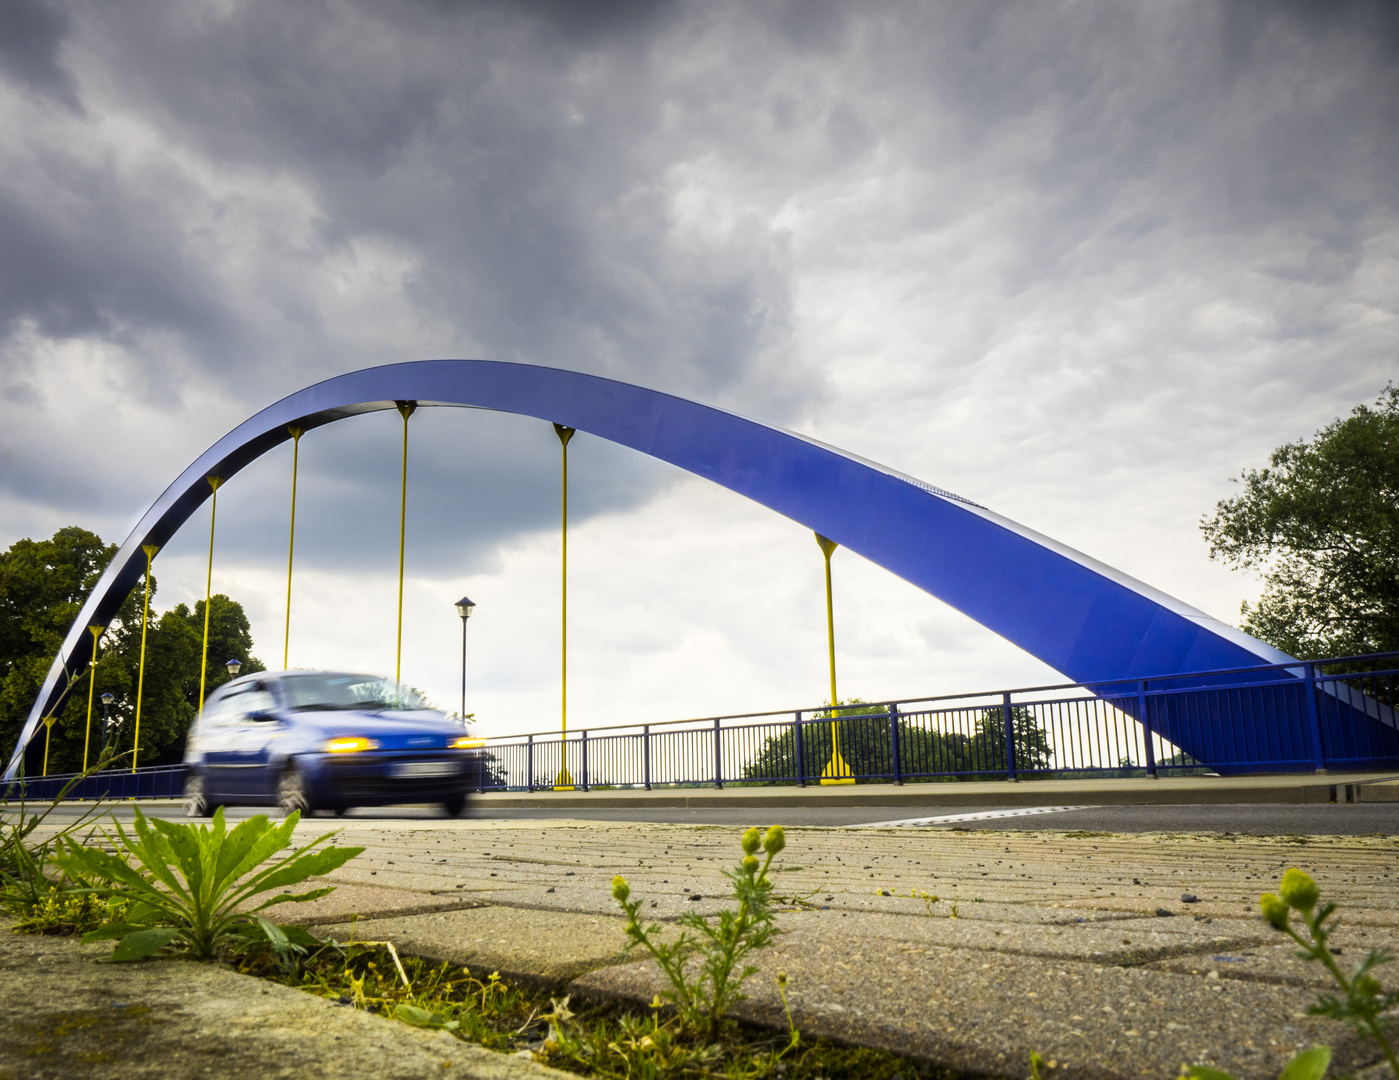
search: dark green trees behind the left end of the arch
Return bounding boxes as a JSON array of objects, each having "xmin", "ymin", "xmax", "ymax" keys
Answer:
[{"xmin": 0, "ymin": 526, "xmax": 263, "ymax": 772}]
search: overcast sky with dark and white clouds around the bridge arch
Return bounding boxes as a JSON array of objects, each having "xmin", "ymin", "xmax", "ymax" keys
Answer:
[{"xmin": 0, "ymin": 0, "xmax": 1399, "ymax": 733}]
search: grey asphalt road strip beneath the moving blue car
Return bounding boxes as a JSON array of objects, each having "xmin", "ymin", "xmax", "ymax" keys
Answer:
[{"xmin": 30, "ymin": 803, "xmax": 1399, "ymax": 837}]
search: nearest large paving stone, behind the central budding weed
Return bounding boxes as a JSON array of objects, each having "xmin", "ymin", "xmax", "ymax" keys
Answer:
[{"xmin": 574, "ymin": 928, "xmax": 1377, "ymax": 1080}]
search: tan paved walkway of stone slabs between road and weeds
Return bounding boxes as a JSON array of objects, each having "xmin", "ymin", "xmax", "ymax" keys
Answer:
[{"xmin": 275, "ymin": 814, "xmax": 1399, "ymax": 1079}]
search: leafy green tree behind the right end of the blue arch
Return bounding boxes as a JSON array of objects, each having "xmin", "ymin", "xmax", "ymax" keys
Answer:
[{"xmin": 1200, "ymin": 383, "xmax": 1399, "ymax": 659}]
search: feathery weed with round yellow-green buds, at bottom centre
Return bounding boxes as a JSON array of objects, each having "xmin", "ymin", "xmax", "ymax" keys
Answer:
[{"xmin": 613, "ymin": 825, "xmax": 796, "ymax": 1045}]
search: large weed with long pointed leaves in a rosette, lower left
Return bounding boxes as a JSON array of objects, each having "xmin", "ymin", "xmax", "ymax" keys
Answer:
[{"xmin": 53, "ymin": 807, "xmax": 364, "ymax": 961}]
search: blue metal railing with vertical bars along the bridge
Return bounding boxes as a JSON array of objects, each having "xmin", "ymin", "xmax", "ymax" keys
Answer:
[{"xmin": 19, "ymin": 653, "xmax": 1399, "ymax": 800}]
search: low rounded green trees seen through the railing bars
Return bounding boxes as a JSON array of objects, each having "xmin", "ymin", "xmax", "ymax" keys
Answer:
[{"xmin": 743, "ymin": 698, "xmax": 1053, "ymax": 782}]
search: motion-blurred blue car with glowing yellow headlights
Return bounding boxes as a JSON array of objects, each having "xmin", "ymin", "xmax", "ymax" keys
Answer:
[{"xmin": 185, "ymin": 672, "xmax": 484, "ymax": 817}]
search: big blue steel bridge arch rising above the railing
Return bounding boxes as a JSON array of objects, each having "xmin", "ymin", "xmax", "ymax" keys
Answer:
[{"xmin": 4, "ymin": 360, "xmax": 1304, "ymax": 779}]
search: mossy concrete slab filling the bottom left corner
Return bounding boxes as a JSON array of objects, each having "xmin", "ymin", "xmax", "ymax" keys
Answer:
[{"xmin": 0, "ymin": 928, "xmax": 569, "ymax": 1080}]
